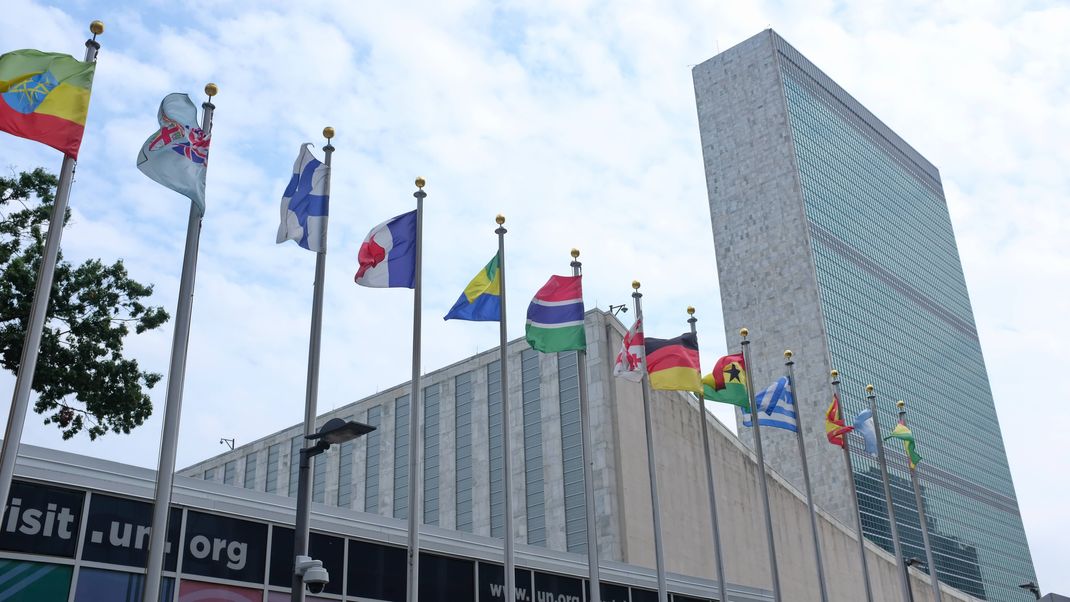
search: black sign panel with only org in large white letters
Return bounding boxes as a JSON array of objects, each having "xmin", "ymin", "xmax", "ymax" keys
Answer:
[{"xmin": 182, "ymin": 510, "xmax": 268, "ymax": 583}]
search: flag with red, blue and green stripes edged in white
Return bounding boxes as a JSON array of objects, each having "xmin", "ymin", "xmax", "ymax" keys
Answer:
[{"xmin": 524, "ymin": 276, "xmax": 587, "ymax": 353}]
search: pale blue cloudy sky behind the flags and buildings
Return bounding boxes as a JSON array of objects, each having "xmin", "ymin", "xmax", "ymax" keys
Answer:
[{"xmin": 0, "ymin": 0, "xmax": 1070, "ymax": 592}]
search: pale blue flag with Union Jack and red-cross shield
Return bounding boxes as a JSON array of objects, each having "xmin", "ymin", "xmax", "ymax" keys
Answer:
[{"xmin": 137, "ymin": 92, "xmax": 212, "ymax": 215}]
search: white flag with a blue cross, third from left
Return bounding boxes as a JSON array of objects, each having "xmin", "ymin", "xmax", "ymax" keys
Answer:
[{"xmin": 275, "ymin": 142, "xmax": 331, "ymax": 252}]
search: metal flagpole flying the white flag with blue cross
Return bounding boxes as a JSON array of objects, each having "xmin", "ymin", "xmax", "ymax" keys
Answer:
[{"xmin": 290, "ymin": 127, "xmax": 334, "ymax": 602}]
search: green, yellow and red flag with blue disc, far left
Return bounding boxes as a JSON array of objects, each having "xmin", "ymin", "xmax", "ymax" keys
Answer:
[{"xmin": 0, "ymin": 50, "xmax": 96, "ymax": 159}]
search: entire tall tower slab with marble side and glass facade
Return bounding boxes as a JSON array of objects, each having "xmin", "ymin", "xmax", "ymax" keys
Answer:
[{"xmin": 693, "ymin": 30, "xmax": 1036, "ymax": 600}]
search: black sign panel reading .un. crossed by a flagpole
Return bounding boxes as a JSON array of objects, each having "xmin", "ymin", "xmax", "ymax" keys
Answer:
[{"xmin": 81, "ymin": 493, "xmax": 182, "ymax": 571}]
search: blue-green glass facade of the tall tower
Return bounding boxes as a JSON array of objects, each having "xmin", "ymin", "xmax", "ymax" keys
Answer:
[{"xmin": 775, "ymin": 36, "xmax": 1036, "ymax": 600}]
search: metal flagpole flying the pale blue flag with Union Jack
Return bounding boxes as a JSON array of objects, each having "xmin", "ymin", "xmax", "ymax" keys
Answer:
[{"xmin": 142, "ymin": 83, "xmax": 219, "ymax": 600}]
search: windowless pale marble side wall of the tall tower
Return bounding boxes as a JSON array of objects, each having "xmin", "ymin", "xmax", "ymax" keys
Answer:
[{"xmin": 692, "ymin": 30, "xmax": 862, "ymax": 524}]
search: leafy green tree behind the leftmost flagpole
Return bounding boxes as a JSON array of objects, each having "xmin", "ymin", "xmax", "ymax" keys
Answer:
[{"xmin": 0, "ymin": 168, "xmax": 169, "ymax": 439}]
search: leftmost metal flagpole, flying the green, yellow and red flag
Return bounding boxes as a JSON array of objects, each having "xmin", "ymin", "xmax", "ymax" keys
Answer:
[{"xmin": 0, "ymin": 21, "xmax": 104, "ymax": 523}]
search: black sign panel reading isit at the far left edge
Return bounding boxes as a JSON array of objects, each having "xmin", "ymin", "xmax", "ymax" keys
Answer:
[{"xmin": 0, "ymin": 481, "xmax": 86, "ymax": 558}]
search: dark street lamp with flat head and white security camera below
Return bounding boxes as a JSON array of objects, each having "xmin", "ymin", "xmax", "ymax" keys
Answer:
[{"xmin": 290, "ymin": 418, "xmax": 376, "ymax": 602}]
